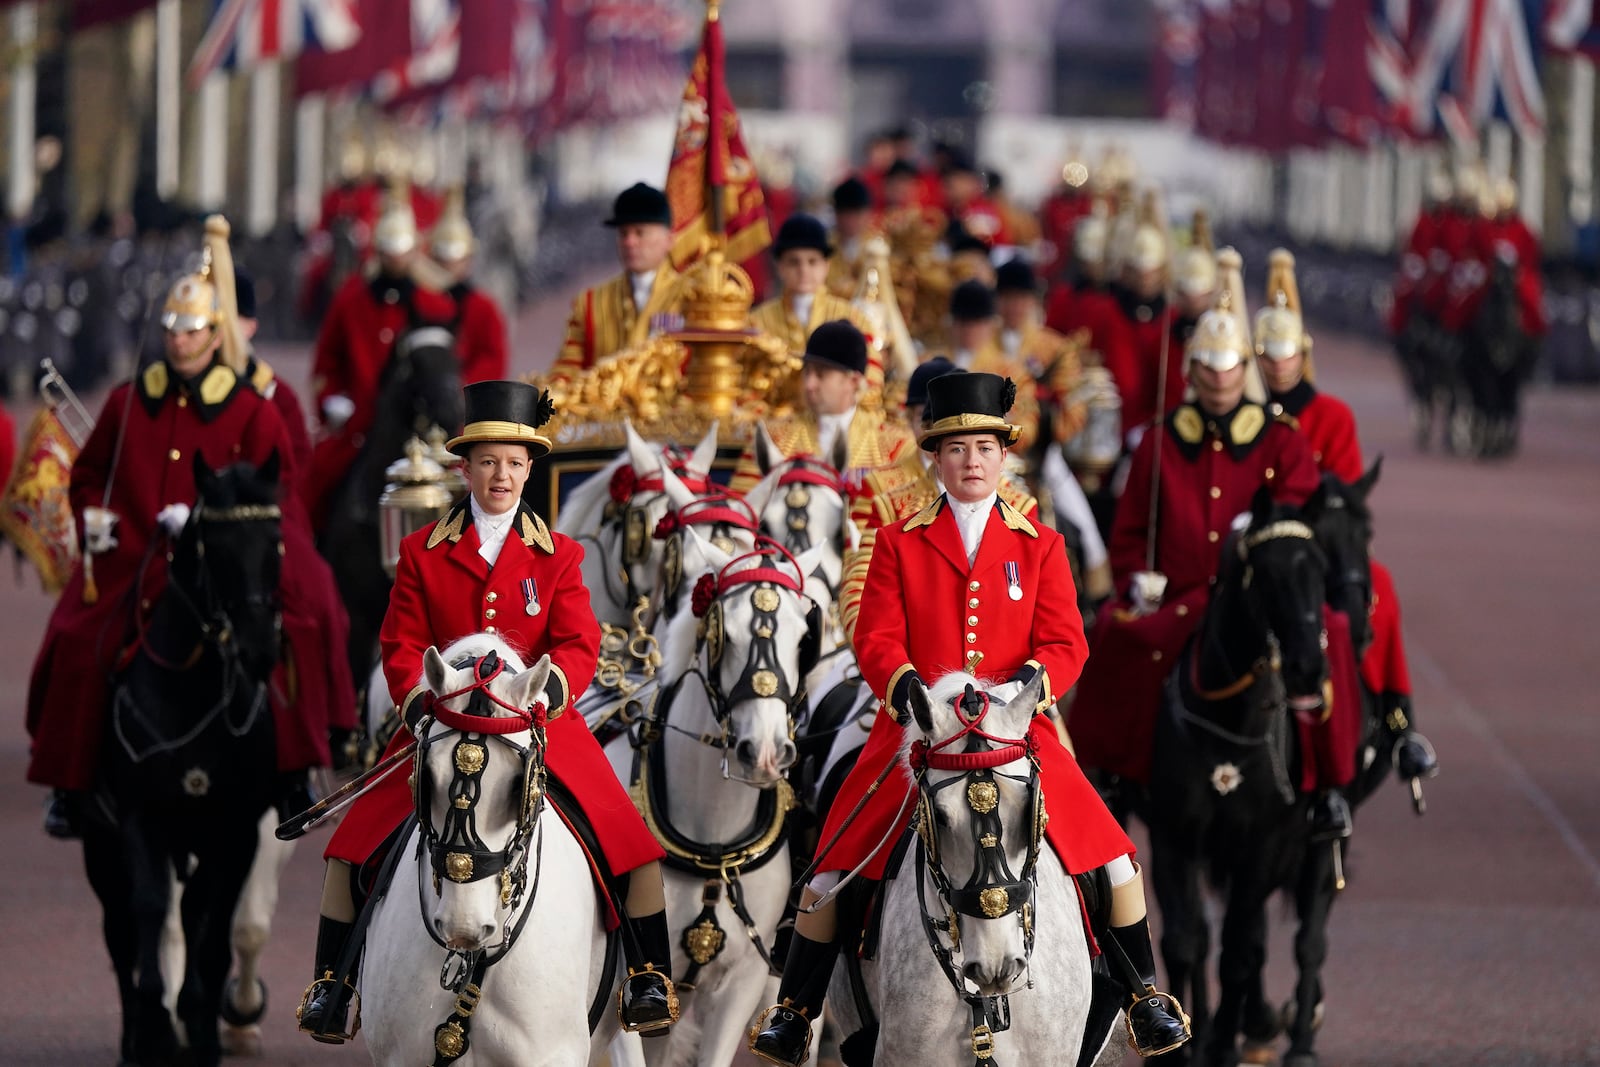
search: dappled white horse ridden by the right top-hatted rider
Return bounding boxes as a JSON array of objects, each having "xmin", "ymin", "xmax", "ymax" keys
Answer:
[{"xmin": 829, "ymin": 673, "xmax": 1106, "ymax": 1067}]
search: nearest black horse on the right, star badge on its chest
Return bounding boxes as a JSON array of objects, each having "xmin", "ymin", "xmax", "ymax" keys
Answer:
[{"xmin": 1146, "ymin": 490, "xmax": 1328, "ymax": 1064}]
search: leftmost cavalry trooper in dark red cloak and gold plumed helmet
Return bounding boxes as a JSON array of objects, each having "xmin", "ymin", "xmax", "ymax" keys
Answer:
[{"xmin": 27, "ymin": 221, "xmax": 354, "ymax": 835}]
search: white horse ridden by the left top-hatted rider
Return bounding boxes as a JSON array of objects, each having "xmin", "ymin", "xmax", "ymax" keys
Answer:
[{"xmin": 360, "ymin": 633, "xmax": 618, "ymax": 1067}]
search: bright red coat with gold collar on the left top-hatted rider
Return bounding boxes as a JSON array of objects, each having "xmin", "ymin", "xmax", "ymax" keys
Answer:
[{"xmin": 325, "ymin": 499, "xmax": 664, "ymax": 873}]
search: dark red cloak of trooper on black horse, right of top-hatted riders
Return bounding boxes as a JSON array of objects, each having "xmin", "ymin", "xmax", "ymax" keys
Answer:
[{"xmin": 1070, "ymin": 402, "xmax": 1320, "ymax": 782}]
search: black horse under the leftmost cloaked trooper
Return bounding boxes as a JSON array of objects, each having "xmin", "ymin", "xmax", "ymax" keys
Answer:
[{"xmin": 83, "ymin": 454, "xmax": 282, "ymax": 1067}]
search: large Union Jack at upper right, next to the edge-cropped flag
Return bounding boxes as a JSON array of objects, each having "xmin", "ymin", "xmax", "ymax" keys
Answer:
[{"xmin": 1368, "ymin": 0, "xmax": 1544, "ymax": 144}]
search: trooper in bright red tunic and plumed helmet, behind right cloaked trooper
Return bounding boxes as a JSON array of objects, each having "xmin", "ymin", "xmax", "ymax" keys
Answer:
[{"xmin": 1256, "ymin": 248, "xmax": 1438, "ymax": 796}]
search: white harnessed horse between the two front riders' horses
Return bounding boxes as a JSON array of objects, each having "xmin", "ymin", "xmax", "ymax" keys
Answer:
[{"xmin": 606, "ymin": 526, "xmax": 819, "ymax": 1067}]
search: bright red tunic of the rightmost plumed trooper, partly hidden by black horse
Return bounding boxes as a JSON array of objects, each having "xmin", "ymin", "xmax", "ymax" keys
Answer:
[{"xmin": 1275, "ymin": 382, "xmax": 1411, "ymax": 700}]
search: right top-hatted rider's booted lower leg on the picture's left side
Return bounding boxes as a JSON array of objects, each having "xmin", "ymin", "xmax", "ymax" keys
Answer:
[{"xmin": 750, "ymin": 870, "xmax": 840, "ymax": 1067}]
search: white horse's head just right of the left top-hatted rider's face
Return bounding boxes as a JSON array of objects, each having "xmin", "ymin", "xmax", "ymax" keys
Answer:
[{"xmin": 555, "ymin": 422, "xmax": 717, "ymax": 629}]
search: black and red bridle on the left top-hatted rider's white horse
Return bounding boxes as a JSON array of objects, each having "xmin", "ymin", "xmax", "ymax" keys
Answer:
[{"xmin": 413, "ymin": 651, "xmax": 549, "ymax": 959}]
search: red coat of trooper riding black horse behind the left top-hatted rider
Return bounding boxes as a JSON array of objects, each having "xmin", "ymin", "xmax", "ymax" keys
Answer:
[{"xmin": 304, "ymin": 275, "xmax": 456, "ymax": 528}]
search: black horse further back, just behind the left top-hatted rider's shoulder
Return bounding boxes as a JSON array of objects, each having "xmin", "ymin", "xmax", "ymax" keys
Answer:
[{"xmin": 317, "ymin": 326, "xmax": 466, "ymax": 685}]
